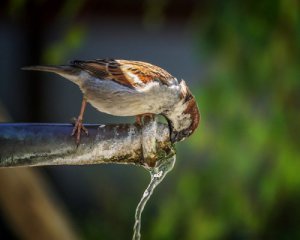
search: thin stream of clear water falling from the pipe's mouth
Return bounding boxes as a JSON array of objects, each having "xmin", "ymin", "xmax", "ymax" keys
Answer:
[{"xmin": 132, "ymin": 155, "xmax": 176, "ymax": 240}]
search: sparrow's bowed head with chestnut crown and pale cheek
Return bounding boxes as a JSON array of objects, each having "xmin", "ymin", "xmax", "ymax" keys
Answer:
[{"xmin": 164, "ymin": 80, "xmax": 200, "ymax": 143}]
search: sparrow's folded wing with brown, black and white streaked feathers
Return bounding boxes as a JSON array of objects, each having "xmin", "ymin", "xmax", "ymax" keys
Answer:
[{"xmin": 71, "ymin": 59, "xmax": 175, "ymax": 88}]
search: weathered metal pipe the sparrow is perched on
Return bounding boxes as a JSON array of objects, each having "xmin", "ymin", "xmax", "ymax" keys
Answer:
[{"xmin": 0, "ymin": 123, "xmax": 174, "ymax": 167}]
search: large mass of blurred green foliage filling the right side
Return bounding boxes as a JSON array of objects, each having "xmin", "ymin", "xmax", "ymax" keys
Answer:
[{"xmin": 152, "ymin": 0, "xmax": 300, "ymax": 239}]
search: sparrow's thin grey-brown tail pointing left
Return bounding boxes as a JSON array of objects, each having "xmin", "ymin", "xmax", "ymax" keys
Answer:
[{"xmin": 21, "ymin": 65, "xmax": 81, "ymax": 84}]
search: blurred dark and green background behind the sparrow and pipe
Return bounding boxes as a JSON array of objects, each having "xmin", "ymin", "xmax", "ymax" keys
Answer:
[{"xmin": 0, "ymin": 0, "xmax": 300, "ymax": 240}]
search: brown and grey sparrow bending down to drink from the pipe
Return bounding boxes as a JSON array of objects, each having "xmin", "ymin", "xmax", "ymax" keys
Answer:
[{"xmin": 22, "ymin": 59, "xmax": 200, "ymax": 144}]
